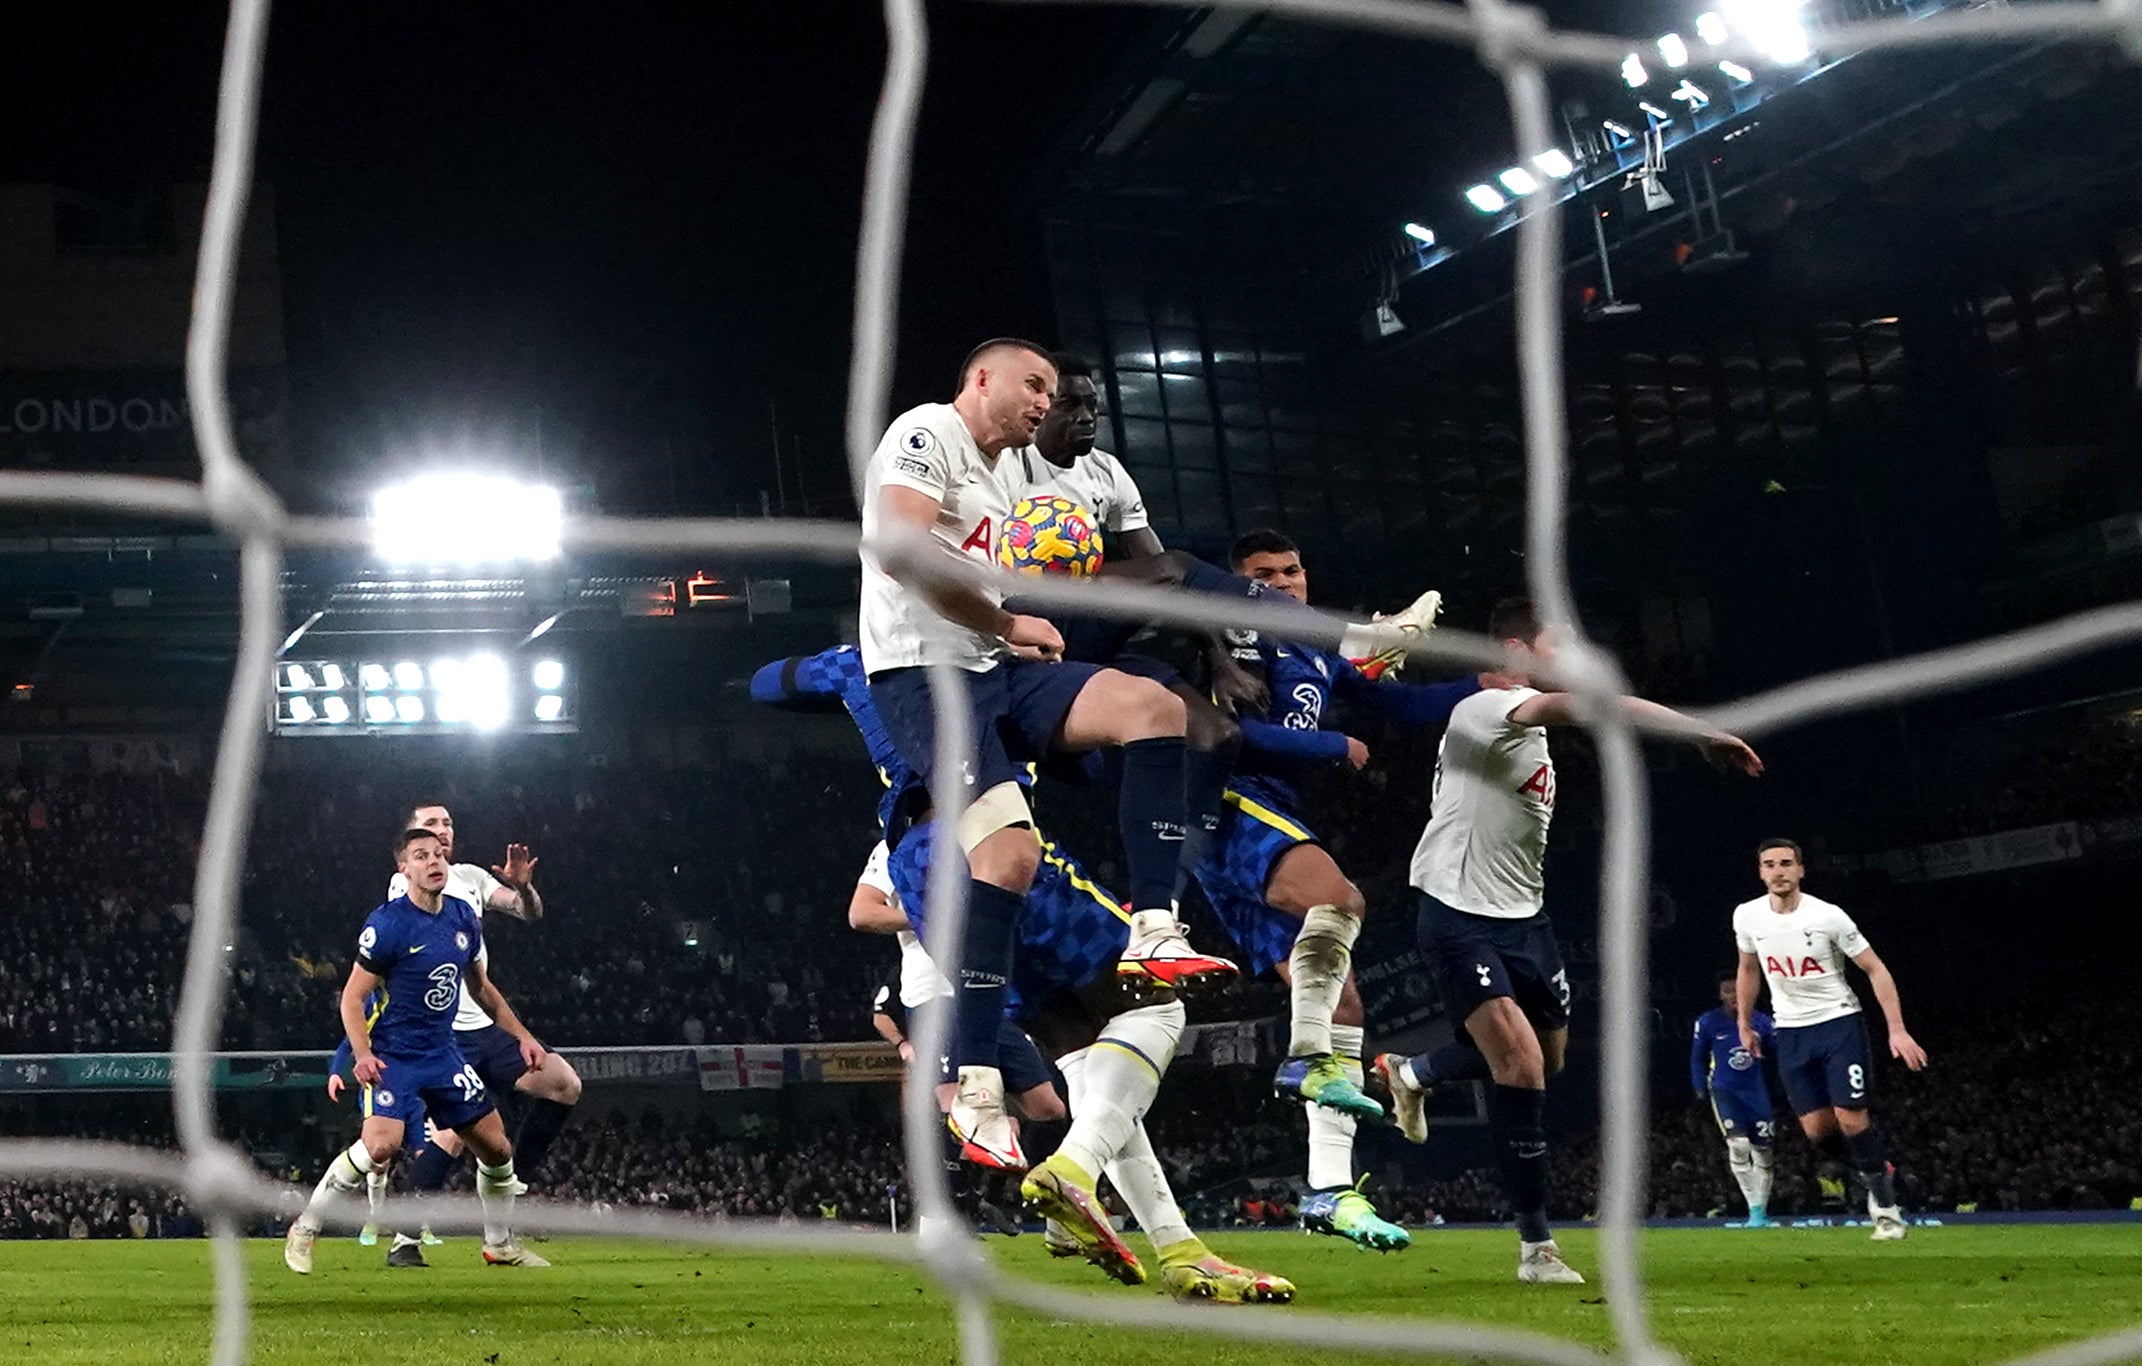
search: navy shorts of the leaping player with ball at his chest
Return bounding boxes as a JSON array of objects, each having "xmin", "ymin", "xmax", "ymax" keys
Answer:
[{"xmin": 870, "ymin": 659, "xmax": 1101, "ymax": 796}]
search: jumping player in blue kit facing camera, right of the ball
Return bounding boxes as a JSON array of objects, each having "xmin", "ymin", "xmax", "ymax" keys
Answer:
[{"xmin": 1197, "ymin": 531, "xmax": 1480, "ymax": 1253}]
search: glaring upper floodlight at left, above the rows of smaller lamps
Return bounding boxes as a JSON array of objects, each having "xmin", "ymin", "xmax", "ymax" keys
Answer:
[{"xmin": 373, "ymin": 471, "xmax": 565, "ymax": 565}]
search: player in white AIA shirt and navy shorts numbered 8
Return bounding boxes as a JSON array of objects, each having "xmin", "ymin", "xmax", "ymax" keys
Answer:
[{"xmin": 1733, "ymin": 839, "xmax": 1926, "ymax": 1242}]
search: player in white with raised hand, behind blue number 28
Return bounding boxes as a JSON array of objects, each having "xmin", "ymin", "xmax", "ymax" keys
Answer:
[{"xmin": 372, "ymin": 801, "xmax": 580, "ymax": 1265}]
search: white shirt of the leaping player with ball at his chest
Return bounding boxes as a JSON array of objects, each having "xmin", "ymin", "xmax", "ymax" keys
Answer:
[{"xmin": 859, "ymin": 403, "xmax": 1015, "ymax": 672}]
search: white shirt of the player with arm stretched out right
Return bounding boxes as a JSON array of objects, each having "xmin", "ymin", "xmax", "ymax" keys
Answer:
[{"xmin": 1412, "ymin": 687, "xmax": 1555, "ymax": 921}]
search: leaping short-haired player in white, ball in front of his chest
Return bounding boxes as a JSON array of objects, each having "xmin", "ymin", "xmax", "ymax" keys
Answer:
[{"xmin": 859, "ymin": 338, "xmax": 1234, "ymax": 1171}]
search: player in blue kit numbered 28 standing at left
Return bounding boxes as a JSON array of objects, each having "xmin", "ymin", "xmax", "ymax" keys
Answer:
[{"xmin": 283, "ymin": 831, "xmax": 546, "ymax": 1274}]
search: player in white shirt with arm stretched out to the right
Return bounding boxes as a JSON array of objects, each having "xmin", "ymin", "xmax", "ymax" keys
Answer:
[{"xmin": 1375, "ymin": 597, "xmax": 1763, "ymax": 1285}]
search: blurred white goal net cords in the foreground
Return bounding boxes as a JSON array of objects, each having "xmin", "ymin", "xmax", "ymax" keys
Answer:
[{"xmin": 0, "ymin": 0, "xmax": 2142, "ymax": 1366}]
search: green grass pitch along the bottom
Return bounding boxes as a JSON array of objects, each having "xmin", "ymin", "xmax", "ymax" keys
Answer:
[{"xmin": 0, "ymin": 1225, "xmax": 2142, "ymax": 1366}]
